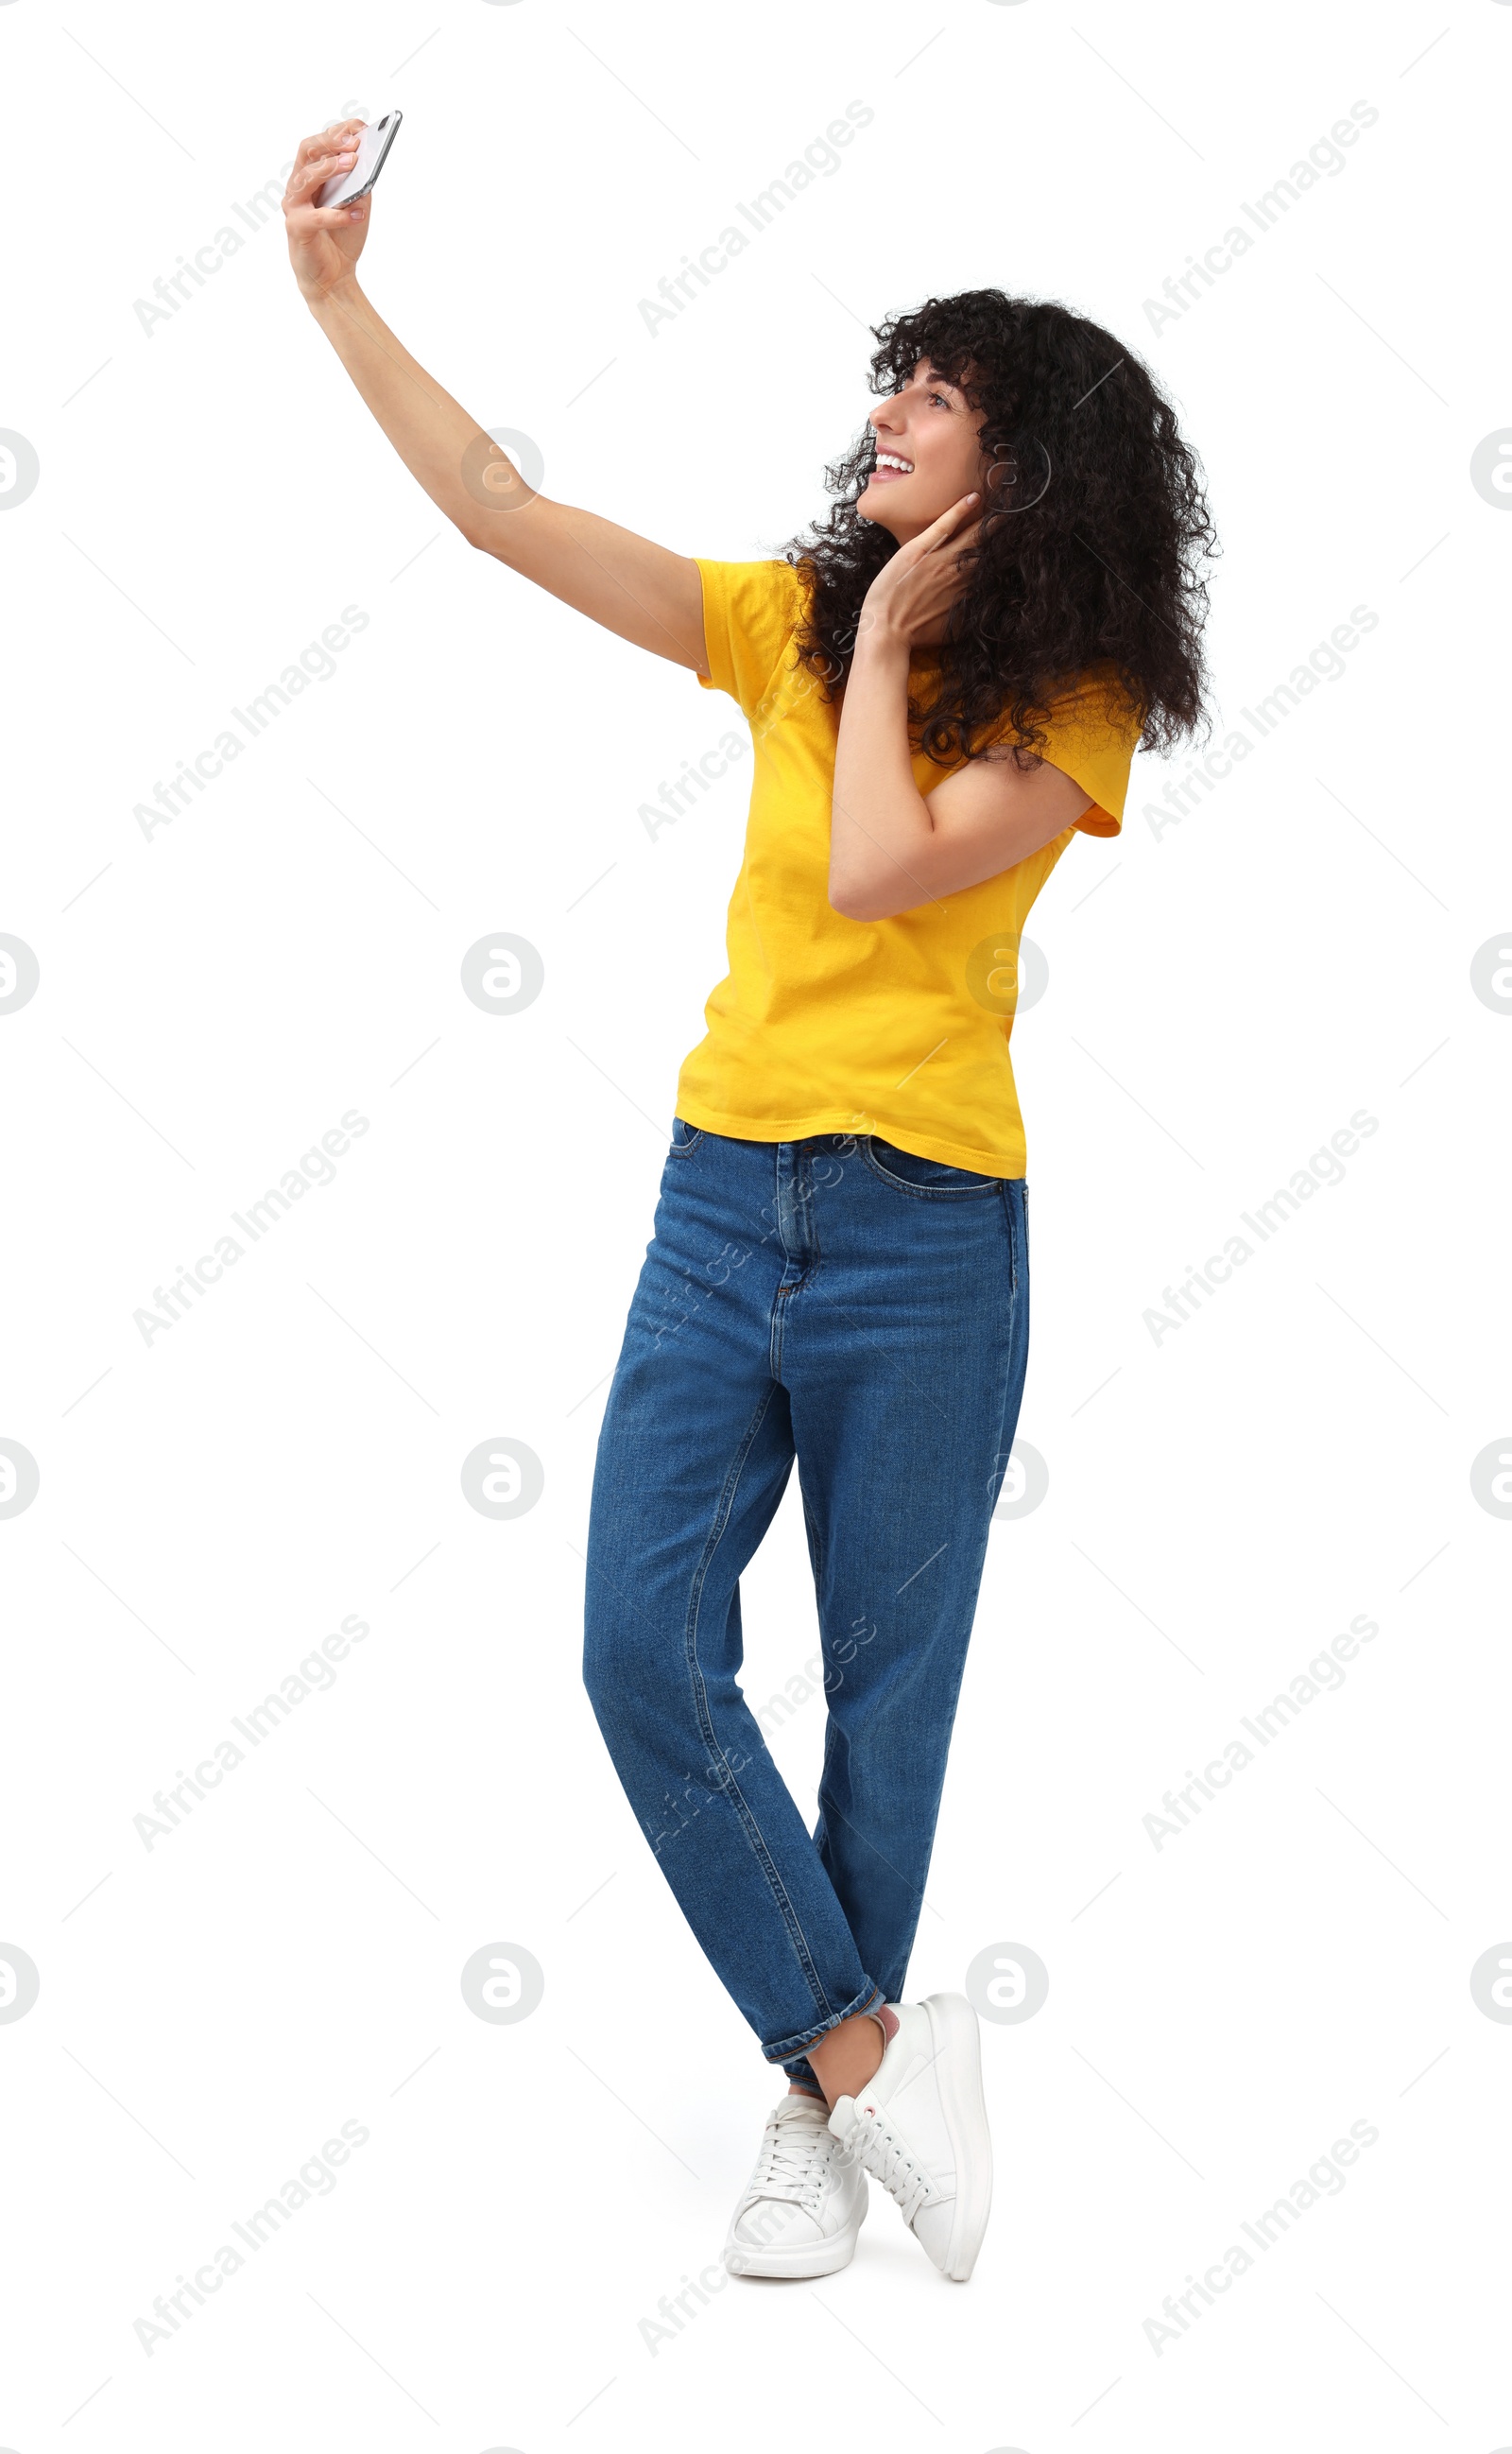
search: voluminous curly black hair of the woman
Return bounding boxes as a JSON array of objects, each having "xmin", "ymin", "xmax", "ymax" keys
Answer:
[{"xmin": 785, "ymin": 289, "xmax": 1217, "ymax": 766}]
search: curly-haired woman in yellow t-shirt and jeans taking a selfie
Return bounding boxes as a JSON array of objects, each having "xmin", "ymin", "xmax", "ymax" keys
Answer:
[{"xmin": 284, "ymin": 120, "xmax": 1212, "ymax": 2282}]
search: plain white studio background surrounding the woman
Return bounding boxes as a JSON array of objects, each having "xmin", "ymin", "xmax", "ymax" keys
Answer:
[{"xmin": 0, "ymin": 0, "xmax": 1512, "ymax": 2454}]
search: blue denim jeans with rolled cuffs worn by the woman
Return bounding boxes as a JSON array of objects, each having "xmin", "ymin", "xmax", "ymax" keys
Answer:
[{"xmin": 584, "ymin": 1119, "xmax": 1028, "ymax": 2088}]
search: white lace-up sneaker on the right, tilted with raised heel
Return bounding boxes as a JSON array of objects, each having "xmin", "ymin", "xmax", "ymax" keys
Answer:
[{"xmin": 830, "ymin": 1996, "xmax": 991, "ymax": 2285}]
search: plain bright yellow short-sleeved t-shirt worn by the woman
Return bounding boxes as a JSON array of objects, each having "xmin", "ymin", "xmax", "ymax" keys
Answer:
[{"xmin": 678, "ymin": 562, "xmax": 1139, "ymax": 1175}]
